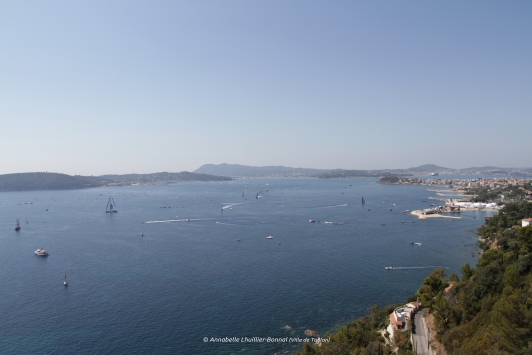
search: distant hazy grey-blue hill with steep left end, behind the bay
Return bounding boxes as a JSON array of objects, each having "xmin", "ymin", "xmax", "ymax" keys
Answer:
[{"xmin": 194, "ymin": 163, "xmax": 325, "ymax": 177}]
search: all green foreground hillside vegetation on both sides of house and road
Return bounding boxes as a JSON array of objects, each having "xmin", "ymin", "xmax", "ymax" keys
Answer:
[{"xmin": 297, "ymin": 202, "xmax": 532, "ymax": 355}]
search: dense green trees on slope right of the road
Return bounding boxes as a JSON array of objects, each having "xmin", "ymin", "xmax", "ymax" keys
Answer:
[{"xmin": 424, "ymin": 203, "xmax": 532, "ymax": 355}]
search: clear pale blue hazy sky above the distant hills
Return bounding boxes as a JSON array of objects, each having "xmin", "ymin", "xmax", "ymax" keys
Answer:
[{"xmin": 0, "ymin": 0, "xmax": 532, "ymax": 175}]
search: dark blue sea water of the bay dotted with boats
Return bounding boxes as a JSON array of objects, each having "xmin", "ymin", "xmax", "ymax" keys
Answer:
[{"xmin": 0, "ymin": 178, "xmax": 489, "ymax": 354}]
